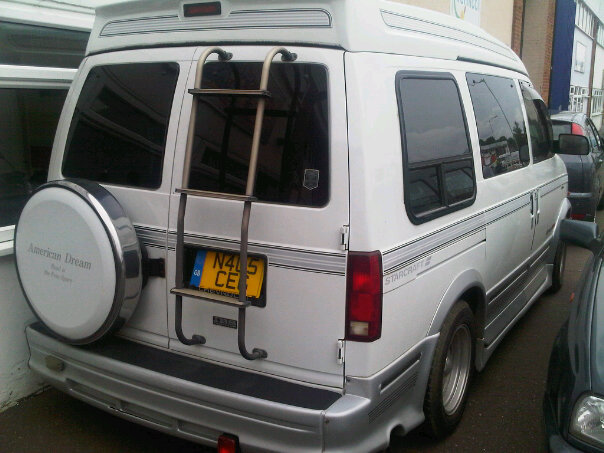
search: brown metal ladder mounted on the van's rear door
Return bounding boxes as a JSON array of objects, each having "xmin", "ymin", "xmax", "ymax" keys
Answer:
[{"xmin": 170, "ymin": 47, "xmax": 297, "ymax": 360}]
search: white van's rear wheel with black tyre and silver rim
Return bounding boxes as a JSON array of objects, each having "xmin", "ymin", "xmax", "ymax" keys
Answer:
[{"xmin": 424, "ymin": 300, "xmax": 476, "ymax": 439}]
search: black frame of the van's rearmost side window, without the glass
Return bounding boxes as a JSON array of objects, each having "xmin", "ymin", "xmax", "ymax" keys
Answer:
[{"xmin": 394, "ymin": 70, "xmax": 477, "ymax": 225}]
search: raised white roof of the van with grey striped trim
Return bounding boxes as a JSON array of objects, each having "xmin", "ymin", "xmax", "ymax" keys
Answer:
[{"xmin": 87, "ymin": 0, "xmax": 526, "ymax": 74}]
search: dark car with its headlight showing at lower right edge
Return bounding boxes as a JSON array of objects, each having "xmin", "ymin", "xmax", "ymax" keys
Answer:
[{"xmin": 543, "ymin": 220, "xmax": 604, "ymax": 453}]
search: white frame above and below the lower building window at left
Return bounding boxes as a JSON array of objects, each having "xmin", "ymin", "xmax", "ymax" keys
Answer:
[{"xmin": 0, "ymin": 65, "xmax": 77, "ymax": 252}]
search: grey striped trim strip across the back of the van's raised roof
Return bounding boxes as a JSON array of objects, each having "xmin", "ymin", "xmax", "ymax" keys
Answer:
[{"xmin": 100, "ymin": 9, "xmax": 332, "ymax": 37}]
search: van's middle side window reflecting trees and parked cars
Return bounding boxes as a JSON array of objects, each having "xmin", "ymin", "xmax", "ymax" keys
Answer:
[{"xmin": 466, "ymin": 73, "xmax": 530, "ymax": 179}]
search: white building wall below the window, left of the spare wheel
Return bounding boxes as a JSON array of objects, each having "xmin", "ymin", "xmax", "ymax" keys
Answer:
[{"xmin": 0, "ymin": 255, "xmax": 42, "ymax": 412}]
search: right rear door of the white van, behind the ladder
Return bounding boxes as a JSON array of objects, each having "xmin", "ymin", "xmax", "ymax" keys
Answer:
[{"xmin": 167, "ymin": 46, "xmax": 349, "ymax": 387}]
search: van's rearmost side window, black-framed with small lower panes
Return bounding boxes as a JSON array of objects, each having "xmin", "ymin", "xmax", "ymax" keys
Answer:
[{"xmin": 396, "ymin": 72, "xmax": 476, "ymax": 224}]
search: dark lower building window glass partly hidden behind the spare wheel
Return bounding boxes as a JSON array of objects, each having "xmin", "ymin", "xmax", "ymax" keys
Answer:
[{"xmin": 0, "ymin": 88, "xmax": 67, "ymax": 227}]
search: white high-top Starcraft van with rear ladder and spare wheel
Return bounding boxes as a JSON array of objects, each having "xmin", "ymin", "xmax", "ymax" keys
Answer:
[{"xmin": 15, "ymin": 0, "xmax": 570, "ymax": 452}]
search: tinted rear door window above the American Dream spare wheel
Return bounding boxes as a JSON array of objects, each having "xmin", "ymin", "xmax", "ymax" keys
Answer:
[{"xmin": 63, "ymin": 63, "xmax": 179, "ymax": 188}]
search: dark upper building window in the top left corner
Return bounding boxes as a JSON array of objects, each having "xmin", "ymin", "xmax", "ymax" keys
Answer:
[{"xmin": 0, "ymin": 21, "xmax": 88, "ymax": 68}]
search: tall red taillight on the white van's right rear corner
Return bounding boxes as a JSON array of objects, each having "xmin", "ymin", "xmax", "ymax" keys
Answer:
[{"xmin": 346, "ymin": 251, "xmax": 382, "ymax": 342}]
